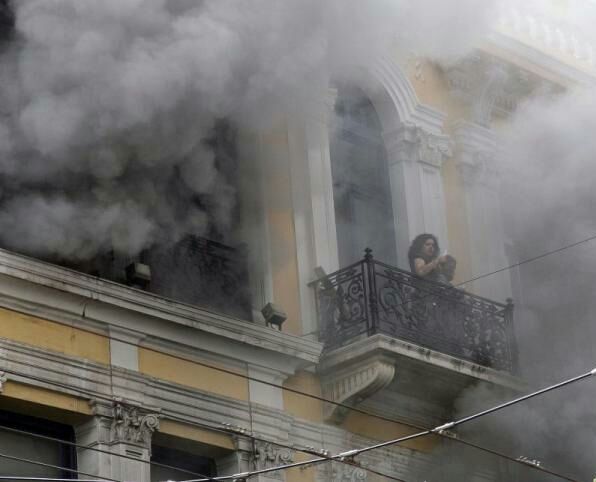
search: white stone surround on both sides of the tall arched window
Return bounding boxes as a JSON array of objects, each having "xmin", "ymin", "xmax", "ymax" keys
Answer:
[{"xmin": 288, "ymin": 58, "xmax": 449, "ymax": 333}]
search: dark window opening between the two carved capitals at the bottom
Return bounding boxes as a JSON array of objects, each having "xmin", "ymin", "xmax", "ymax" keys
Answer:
[{"xmin": 151, "ymin": 444, "xmax": 217, "ymax": 482}]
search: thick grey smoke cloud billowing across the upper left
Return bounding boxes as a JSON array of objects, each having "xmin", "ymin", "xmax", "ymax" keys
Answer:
[{"xmin": 0, "ymin": 0, "xmax": 491, "ymax": 258}]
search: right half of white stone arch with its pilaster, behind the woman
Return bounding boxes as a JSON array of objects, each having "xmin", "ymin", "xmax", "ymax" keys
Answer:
[{"xmin": 336, "ymin": 58, "xmax": 450, "ymax": 269}]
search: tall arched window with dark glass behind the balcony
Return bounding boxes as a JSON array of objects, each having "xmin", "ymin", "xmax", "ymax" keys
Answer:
[{"xmin": 329, "ymin": 86, "xmax": 396, "ymax": 266}]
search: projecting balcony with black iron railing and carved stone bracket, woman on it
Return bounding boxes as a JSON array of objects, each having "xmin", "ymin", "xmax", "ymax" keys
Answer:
[{"xmin": 313, "ymin": 249, "xmax": 523, "ymax": 424}]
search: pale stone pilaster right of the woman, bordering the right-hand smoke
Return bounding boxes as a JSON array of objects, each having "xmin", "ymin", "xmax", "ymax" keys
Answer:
[{"xmin": 454, "ymin": 122, "xmax": 511, "ymax": 302}]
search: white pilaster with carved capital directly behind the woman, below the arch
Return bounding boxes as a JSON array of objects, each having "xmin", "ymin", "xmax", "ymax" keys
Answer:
[{"xmin": 384, "ymin": 124, "xmax": 451, "ymax": 269}]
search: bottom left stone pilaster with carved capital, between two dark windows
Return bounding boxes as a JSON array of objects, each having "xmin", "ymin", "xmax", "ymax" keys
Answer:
[{"xmin": 75, "ymin": 400, "xmax": 160, "ymax": 482}]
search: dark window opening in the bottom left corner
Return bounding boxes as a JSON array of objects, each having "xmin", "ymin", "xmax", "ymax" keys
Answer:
[{"xmin": 0, "ymin": 410, "xmax": 77, "ymax": 479}]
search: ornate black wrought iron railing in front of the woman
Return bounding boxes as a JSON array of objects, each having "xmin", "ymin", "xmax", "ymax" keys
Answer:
[{"xmin": 315, "ymin": 249, "xmax": 517, "ymax": 372}]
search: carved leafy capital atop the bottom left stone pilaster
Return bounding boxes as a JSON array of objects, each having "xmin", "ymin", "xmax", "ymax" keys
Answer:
[{"xmin": 90, "ymin": 399, "xmax": 161, "ymax": 448}]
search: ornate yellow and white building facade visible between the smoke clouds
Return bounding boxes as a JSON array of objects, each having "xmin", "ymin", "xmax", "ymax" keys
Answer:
[{"xmin": 0, "ymin": 1, "xmax": 594, "ymax": 482}]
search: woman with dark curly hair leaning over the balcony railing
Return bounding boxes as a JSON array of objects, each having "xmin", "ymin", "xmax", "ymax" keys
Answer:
[{"xmin": 408, "ymin": 233, "xmax": 456, "ymax": 284}]
